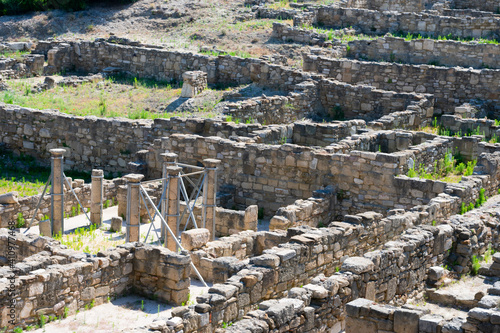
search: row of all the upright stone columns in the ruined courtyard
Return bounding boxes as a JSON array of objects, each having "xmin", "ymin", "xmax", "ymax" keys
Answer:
[{"xmin": 50, "ymin": 149, "xmax": 221, "ymax": 251}]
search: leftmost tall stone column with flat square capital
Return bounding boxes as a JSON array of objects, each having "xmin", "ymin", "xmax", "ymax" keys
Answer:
[{"xmin": 50, "ymin": 148, "xmax": 66, "ymax": 235}]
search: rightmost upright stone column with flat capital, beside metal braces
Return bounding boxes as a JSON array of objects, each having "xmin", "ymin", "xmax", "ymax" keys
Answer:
[{"xmin": 203, "ymin": 158, "xmax": 221, "ymax": 240}]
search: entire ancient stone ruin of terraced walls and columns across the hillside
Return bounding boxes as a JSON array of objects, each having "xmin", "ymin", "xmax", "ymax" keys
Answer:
[{"xmin": 0, "ymin": 0, "xmax": 500, "ymax": 333}]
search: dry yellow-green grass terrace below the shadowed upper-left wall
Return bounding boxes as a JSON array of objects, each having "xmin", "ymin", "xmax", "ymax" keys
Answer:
[{"xmin": 0, "ymin": 76, "xmax": 217, "ymax": 119}]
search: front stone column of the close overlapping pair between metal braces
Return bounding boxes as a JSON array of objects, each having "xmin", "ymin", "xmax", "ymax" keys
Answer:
[{"xmin": 165, "ymin": 166, "xmax": 182, "ymax": 252}]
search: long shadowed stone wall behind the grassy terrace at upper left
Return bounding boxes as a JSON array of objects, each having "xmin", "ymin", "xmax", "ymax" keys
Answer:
[{"xmin": 34, "ymin": 40, "xmax": 320, "ymax": 91}]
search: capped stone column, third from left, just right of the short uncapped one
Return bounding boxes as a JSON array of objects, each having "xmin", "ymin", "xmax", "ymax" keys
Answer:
[{"xmin": 125, "ymin": 173, "xmax": 144, "ymax": 243}]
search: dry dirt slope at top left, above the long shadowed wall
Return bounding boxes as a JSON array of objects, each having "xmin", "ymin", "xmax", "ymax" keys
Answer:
[{"xmin": 0, "ymin": 0, "xmax": 303, "ymax": 60}]
